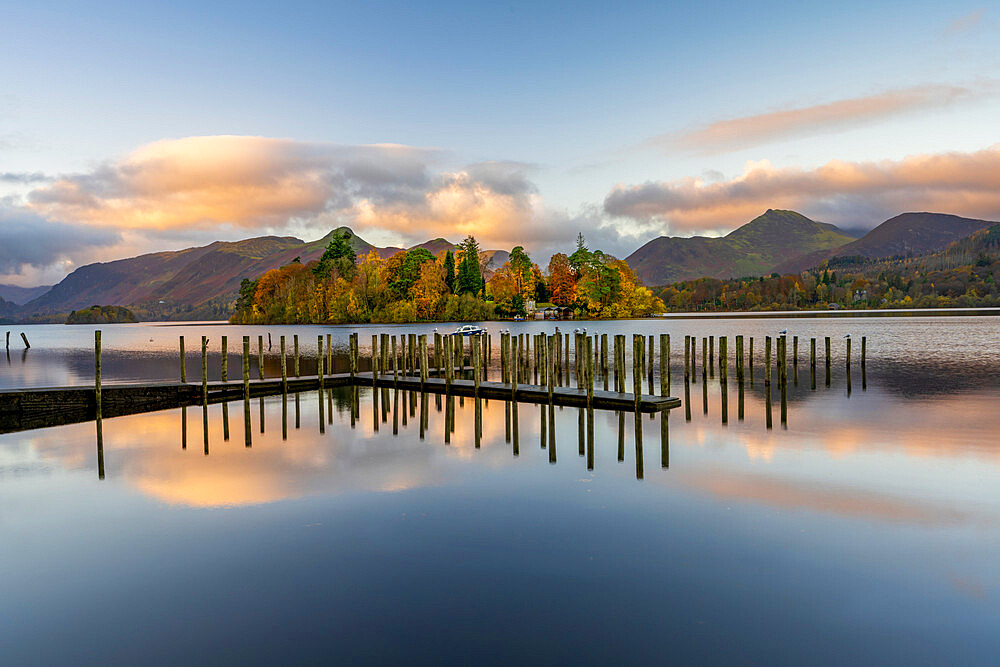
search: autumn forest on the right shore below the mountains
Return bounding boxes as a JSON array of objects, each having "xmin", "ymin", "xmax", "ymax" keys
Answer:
[{"xmin": 657, "ymin": 225, "xmax": 1000, "ymax": 312}]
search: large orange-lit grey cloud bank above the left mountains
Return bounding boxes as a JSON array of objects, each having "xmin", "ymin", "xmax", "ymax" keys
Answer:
[{"xmin": 28, "ymin": 136, "xmax": 568, "ymax": 253}]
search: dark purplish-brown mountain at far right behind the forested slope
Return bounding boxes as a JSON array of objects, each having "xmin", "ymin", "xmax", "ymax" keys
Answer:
[{"xmin": 834, "ymin": 213, "xmax": 996, "ymax": 257}]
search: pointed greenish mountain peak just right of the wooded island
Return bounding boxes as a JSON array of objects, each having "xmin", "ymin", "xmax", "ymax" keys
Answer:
[{"xmin": 625, "ymin": 209, "xmax": 853, "ymax": 285}]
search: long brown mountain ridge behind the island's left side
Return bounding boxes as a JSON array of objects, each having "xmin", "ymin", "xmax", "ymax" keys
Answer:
[{"xmin": 17, "ymin": 227, "xmax": 508, "ymax": 320}]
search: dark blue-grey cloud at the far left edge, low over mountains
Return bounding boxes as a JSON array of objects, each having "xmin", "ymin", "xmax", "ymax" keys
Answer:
[{"xmin": 0, "ymin": 208, "xmax": 121, "ymax": 274}]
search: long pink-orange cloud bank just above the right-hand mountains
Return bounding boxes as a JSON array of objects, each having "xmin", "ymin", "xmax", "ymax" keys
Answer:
[{"xmin": 604, "ymin": 144, "xmax": 1000, "ymax": 232}]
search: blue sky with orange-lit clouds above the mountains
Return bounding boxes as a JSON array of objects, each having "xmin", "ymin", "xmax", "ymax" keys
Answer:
[{"xmin": 0, "ymin": 1, "xmax": 1000, "ymax": 286}]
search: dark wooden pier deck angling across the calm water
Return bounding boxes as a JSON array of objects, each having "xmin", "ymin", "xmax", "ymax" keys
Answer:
[{"xmin": 0, "ymin": 372, "xmax": 681, "ymax": 433}]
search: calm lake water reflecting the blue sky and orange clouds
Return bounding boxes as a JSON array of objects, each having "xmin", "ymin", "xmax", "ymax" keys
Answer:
[{"xmin": 0, "ymin": 315, "xmax": 1000, "ymax": 664}]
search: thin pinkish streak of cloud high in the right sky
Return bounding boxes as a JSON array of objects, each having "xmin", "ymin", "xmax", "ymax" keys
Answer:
[{"xmin": 646, "ymin": 82, "xmax": 997, "ymax": 154}]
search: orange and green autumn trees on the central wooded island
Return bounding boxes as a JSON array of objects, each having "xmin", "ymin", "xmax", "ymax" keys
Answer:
[{"xmin": 230, "ymin": 234, "xmax": 664, "ymax": 324}]
